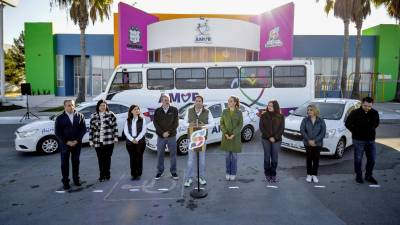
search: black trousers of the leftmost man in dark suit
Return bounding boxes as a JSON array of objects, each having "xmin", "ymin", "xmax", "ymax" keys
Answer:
[{"xmin": 60, "ymin": 144, "xmax": 81, "ymax": 183}]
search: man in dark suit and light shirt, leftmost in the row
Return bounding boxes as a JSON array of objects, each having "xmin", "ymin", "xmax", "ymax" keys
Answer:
[{"xmin": 55, "ymin": 100, "xmax": 86, "ymax": 190}]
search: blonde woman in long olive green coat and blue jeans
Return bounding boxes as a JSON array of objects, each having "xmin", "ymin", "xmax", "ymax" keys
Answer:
[{"xmin": 221, "ymin": 96, "xmax": 243, "ymax": 180}]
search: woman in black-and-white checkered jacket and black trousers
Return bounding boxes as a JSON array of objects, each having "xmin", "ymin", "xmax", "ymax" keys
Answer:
[{"xmin": 89, "ymin": 100, "xmax": 118, "ymax": 182}]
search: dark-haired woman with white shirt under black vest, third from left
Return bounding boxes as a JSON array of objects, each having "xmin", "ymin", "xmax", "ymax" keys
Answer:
[{"xmin": 124, "ymin": 105, "xmax": 147, "ymax": 180}]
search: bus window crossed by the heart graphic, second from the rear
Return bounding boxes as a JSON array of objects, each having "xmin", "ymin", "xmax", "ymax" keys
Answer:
[{"xmin": 240, "ymin": 66, "xmax": 272, "ymax": 88}]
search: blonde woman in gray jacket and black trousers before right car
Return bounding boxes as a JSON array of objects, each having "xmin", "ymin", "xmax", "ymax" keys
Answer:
[{"xmin": 300, "ymin": 105, "xmax": 326, "ymax": 183}]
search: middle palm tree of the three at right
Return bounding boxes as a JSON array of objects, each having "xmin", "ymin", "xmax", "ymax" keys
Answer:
[{"xmin": 351, "ymin": 0, "xmax": 371, "ymax": 99}]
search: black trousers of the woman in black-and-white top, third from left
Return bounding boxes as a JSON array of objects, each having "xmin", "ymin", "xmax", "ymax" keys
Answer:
[{"xmin": 126, "ymin": 141, "xmax": 146, "ymax": 177}]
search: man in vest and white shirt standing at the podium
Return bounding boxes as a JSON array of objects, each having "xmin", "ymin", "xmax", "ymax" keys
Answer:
[{"xmin": 184, "ymin": 95, "xmax": 214, "ymax": 187}]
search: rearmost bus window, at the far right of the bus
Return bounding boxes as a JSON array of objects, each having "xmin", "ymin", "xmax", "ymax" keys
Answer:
[{"xmin": 274, "ymin": 66, "xmax": 306, "ymax": 88}]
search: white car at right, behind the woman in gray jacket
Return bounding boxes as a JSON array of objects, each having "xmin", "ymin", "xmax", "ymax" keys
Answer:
[{"xmin": 282, "ymin": 98, "xmax": 361, "ymax": 158}]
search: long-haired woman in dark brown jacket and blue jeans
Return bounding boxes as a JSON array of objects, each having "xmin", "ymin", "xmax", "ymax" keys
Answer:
[{"xmin": 260, "ymin": 100, "xmax": 285, "ymax": 183}]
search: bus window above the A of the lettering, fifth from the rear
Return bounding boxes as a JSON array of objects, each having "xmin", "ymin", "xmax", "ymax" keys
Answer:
[{"xmin": 147, "ymin": 69, "xmax": 174, "ymax": 90}]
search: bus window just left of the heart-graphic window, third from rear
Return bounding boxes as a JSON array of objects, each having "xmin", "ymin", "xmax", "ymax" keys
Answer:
[{"xmin": 207, "ymin": 67, "xmax": 239, "ymax": 89}]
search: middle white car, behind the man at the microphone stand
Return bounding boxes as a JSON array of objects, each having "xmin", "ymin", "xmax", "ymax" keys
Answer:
[{"xmin": 145, "ymin": 102, "xmax": 260, "ymax": 155}]
